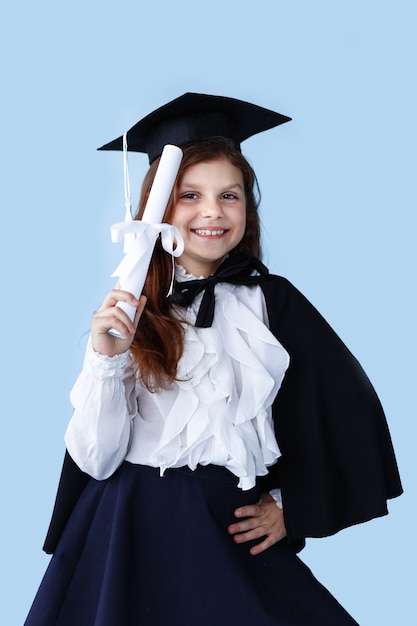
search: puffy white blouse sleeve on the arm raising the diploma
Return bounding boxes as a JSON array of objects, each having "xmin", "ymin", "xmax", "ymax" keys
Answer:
[{"xmin": 65, "ymin": 342, "xmax": 137, "ymax": 480}]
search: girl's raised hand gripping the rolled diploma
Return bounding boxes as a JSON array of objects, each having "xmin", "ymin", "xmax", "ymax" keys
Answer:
[{"xmin": 91, "ymin": 289, "xmax": 146, "ymax": 357}]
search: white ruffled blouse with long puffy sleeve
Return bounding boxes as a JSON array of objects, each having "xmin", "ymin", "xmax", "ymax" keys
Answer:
[{"xmin": 65, "ymin": 267, "xmax": 289, "ymax": 490}]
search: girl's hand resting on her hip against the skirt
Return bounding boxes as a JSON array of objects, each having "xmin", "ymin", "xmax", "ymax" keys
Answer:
[{"xmin": 228, "ymin": 493, "xmax": 287, "ymax": 555}]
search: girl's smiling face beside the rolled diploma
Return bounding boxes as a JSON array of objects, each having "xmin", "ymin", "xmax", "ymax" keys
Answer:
[{"xmin": 170, "ymin": 158, "xmax": 246, "ymax": 277}]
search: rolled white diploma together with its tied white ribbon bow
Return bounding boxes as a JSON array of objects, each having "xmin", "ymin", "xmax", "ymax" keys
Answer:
[{"xmin": 109, "ymin": 145, "xmax": 184, "ymax": 337}]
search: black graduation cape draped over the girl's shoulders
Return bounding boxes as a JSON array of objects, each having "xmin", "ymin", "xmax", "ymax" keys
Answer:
[{"xmin": 43, "ymin": 274, "xmax": 402, "ymax": 554}]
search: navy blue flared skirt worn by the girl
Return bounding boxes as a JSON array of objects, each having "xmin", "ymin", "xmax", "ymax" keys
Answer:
[{"xmin": 25, "ymin": 462, "xmax": 357, "ymax": 626}]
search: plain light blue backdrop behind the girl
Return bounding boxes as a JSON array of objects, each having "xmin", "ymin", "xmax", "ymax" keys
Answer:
[{"xmin": 0, "ymin": 0, "xmax": 417, "ymax": 626}]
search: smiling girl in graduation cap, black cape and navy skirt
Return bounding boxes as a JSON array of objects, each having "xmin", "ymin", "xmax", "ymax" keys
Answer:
[{"xmin": 26, "ymin": 94, "xmax": 401, "ymax": 626}]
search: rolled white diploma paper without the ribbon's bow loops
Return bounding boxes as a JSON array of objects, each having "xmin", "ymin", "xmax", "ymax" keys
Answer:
[{"xmin": 109, "ymin": 144, "xmax": 182, "ymax": 336}]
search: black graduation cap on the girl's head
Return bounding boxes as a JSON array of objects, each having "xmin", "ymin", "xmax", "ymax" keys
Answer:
[{"xmin": 98, "ymin": 93, "xmax": 291, "ymax": 163}]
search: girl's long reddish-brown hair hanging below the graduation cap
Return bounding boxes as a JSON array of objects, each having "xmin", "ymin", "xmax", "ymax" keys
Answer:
[{"xmin": 131, "ymin": 137, "xmax": 261, "ymax": 391}]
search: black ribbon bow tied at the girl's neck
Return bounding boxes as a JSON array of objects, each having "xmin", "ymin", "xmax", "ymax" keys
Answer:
[{"xmin": 172, "ymin": 252, "xmax": 269, "ymax": 328}]
